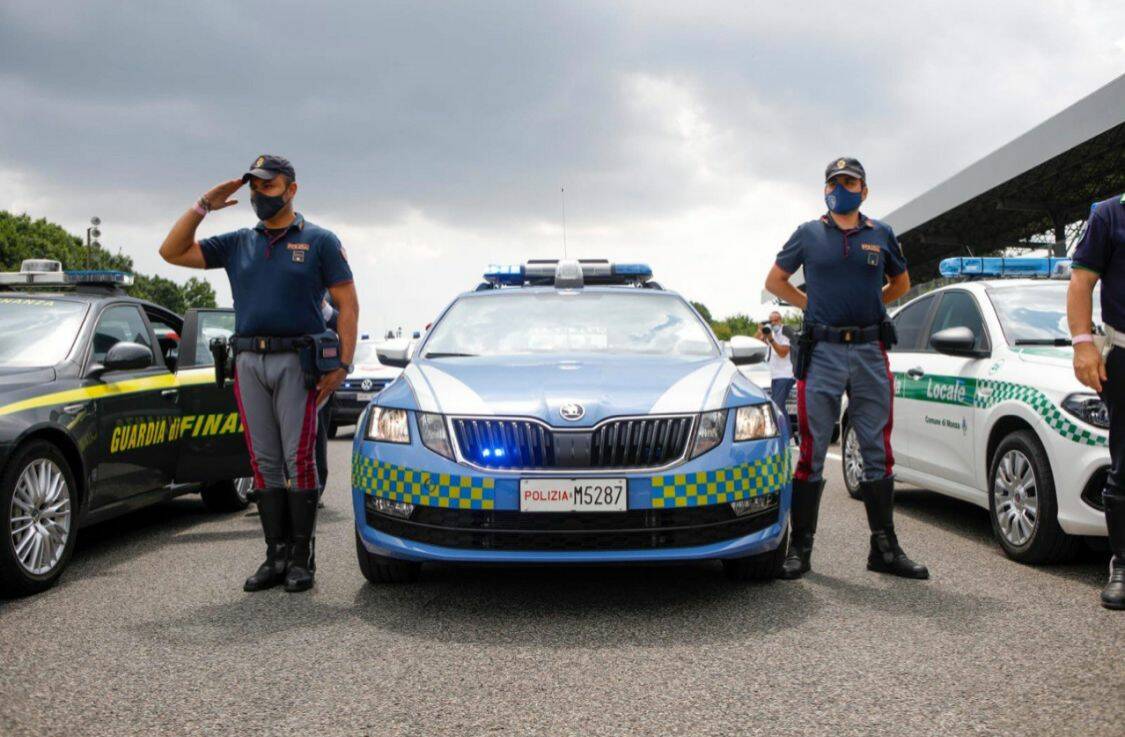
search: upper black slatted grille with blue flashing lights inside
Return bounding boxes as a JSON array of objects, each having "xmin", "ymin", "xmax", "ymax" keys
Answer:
[{"xmin": 452, "ymin": 415, "xmax": 694, "ymax": 469}]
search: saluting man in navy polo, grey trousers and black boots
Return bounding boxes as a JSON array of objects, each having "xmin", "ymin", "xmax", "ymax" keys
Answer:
[{"xmin": 160, "ymin": 155, "xmax": 359, "ymax": 592}]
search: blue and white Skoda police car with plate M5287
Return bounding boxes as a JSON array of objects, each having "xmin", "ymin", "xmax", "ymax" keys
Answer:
[{"xmin": 352, "ymin": 260, "xmax": 791, "ymax": 582}]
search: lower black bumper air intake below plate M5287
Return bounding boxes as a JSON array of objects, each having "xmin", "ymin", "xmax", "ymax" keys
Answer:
[{"xmin": 366, "ymin": 497, "xmax": 779, "ymax": 550}]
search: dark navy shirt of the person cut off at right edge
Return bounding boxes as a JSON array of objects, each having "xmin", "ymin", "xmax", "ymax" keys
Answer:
[{"xmin": 1071, "ymin": 195, "xmax": 1125, "ymax": 331}]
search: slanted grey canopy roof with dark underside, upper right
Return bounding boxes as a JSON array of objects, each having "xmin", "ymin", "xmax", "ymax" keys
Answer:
[{"xmin": 884, "ymin": 74, "xmax": 1125, "ymax": 282}]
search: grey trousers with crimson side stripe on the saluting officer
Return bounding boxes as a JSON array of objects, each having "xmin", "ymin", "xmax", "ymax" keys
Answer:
[{"xmin": 234, "ymin": 351, "xmax": 317, "ymax": 488}]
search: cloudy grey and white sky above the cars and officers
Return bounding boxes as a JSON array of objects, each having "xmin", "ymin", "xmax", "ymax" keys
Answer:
[{"xmin": 0, "ymin": 0, "xmax": 1125, "ymax": 332}]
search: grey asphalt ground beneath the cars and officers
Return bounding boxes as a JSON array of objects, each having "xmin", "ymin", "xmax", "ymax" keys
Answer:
[{"xmin": 0, "ymin": 434, "xmax": 1125, "ymax": 737}]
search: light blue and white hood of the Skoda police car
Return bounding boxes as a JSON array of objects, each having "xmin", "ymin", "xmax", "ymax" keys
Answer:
[{"xmin": 379, "ymin": 356, "xmax": 765, "ymax": 426}]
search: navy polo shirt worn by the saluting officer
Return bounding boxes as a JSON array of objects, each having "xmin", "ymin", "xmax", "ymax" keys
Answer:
[{"xmin": 199, "ymin": 213, "xmax": 352, "ymax": 336}]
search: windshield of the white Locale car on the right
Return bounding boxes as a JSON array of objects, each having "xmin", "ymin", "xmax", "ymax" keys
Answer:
[{"xmin": 988, "ymin": 281, "xmax": 1101, "ymax": 345}]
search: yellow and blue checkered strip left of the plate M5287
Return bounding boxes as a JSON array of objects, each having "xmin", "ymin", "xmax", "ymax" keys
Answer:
[{"xmin": 352, "ymin": 455, "xmax": 496, "ymax": 510}]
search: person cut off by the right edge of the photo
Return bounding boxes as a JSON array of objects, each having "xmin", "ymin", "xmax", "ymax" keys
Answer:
[{"xmin": 1067, "ymin": 195, "xmax": 1125, "ymax": 610}]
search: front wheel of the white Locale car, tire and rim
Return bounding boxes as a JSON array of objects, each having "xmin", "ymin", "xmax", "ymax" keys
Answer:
[{"xmin": 988, "ymin": 430, "xmax": 1078, "ymax": 564}]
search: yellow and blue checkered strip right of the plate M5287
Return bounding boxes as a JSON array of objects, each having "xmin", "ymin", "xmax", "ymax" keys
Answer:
[{"xmin": 653, "ymin": 450, "xmax": 793, "ymax": 509}]
